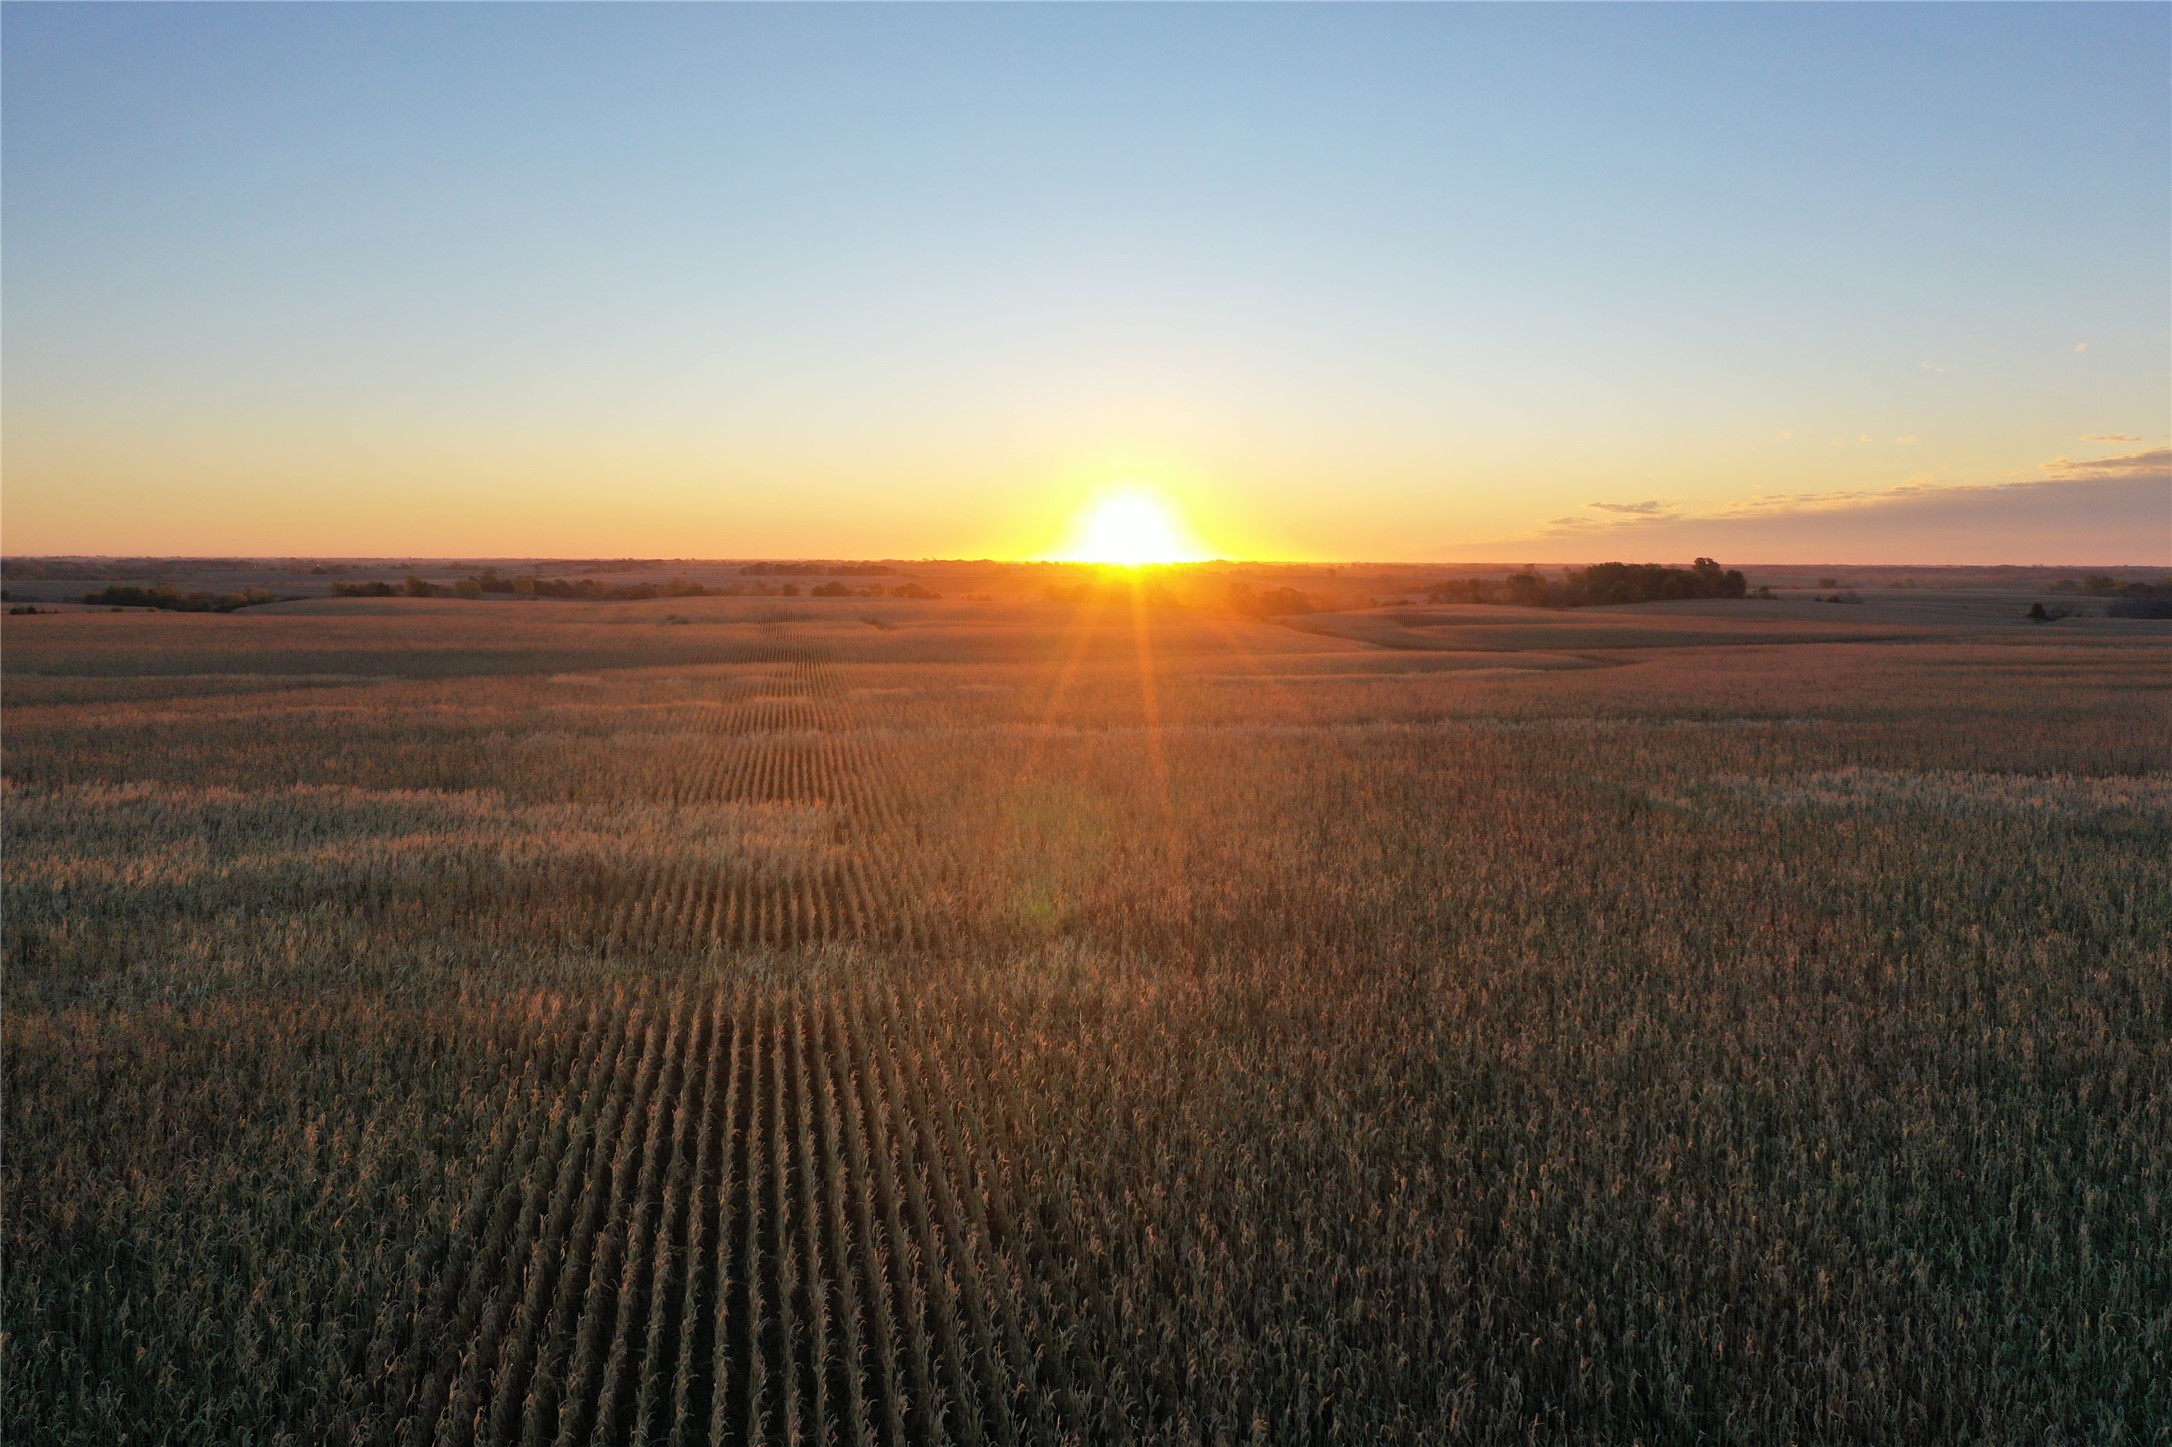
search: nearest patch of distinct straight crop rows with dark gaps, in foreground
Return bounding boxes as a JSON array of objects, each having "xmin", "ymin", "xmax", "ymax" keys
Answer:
[{"xmin": 345, "ymin": 984, "xmax": 1030, "ymax": 1447}]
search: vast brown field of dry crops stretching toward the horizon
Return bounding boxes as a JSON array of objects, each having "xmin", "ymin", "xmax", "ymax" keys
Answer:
[{"xmin": 0, "ymin": 589, "xmax": 2172, "ymax": 1447}]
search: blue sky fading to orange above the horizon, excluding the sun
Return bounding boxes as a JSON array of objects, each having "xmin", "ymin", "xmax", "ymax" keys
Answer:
[{"xmin": 0, "ymin": 4, "xmax": 2172, "ymax": 565}]
